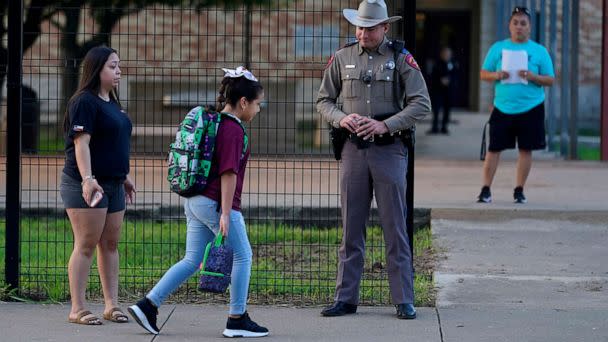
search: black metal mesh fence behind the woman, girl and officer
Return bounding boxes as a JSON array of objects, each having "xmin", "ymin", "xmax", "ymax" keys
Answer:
[{"xmin": 0, "ymin": 0, "xmax": 418, "ymax": 304}]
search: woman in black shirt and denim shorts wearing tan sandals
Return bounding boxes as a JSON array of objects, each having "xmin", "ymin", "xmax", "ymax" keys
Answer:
[{"xmin": 60, "ymin": 46, "xmax": 135, "ymax": 325}]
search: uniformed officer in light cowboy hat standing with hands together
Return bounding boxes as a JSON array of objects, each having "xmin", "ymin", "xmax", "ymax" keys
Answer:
[{"xmin": 317, "ymin": 0, "xmax": 431, "ymax": 319}]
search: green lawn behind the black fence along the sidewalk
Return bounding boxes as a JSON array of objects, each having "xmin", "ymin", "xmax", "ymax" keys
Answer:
[{"xmin": 0, "ymin": 218, "xmax": 435, "ymax": 306}]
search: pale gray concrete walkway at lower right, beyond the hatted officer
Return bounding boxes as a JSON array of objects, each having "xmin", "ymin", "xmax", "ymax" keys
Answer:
[{"xmin": 432, "ymin": 210, "xmax": 608, "ymax": 342}]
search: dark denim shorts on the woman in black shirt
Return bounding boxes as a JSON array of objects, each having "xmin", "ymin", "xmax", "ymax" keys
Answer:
[{"xmin": 59, "ymin": 172, "xmax": 127, "ymax": 213}]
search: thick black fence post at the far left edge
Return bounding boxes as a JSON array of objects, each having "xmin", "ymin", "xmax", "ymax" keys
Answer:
[{"xmin": 4, "ymin": 0, "xmax": 23, "ymax": 289}]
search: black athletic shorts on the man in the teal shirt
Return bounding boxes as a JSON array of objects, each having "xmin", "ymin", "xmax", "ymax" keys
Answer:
[{"xmin": 488, "ymin": 103, "xmax": 547, "ymax": 152}]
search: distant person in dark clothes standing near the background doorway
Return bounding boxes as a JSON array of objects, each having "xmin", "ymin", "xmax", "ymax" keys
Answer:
[{"xmin": 427, "ymin": 47, "xmax": 457, "ymax": 134}]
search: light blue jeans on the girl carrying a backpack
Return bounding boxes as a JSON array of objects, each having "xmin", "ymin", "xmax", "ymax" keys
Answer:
[{"xmin": 146, "ymin": 196, "xmax": 253, "ymax": 315}]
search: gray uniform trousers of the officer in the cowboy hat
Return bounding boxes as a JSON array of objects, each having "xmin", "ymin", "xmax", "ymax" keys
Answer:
[{"xmin": 335, "ymin": 139, "xmax": 414, "ymax": 304}]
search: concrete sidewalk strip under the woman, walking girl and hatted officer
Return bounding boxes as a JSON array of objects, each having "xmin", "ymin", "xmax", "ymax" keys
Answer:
[{"xmin": 0, "ymin": 303, "xmax": 441, "ymax": 342}]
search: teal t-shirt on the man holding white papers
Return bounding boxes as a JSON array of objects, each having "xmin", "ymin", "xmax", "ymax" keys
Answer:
[{"xmin": 481, "ymin": 39, "xmax": 555, "ymax": 114}]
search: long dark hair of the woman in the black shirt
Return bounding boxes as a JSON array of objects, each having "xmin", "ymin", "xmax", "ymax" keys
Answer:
[{"xmin": 63, "ymin": 46, "xmax": 122, "ymax": 133}]
